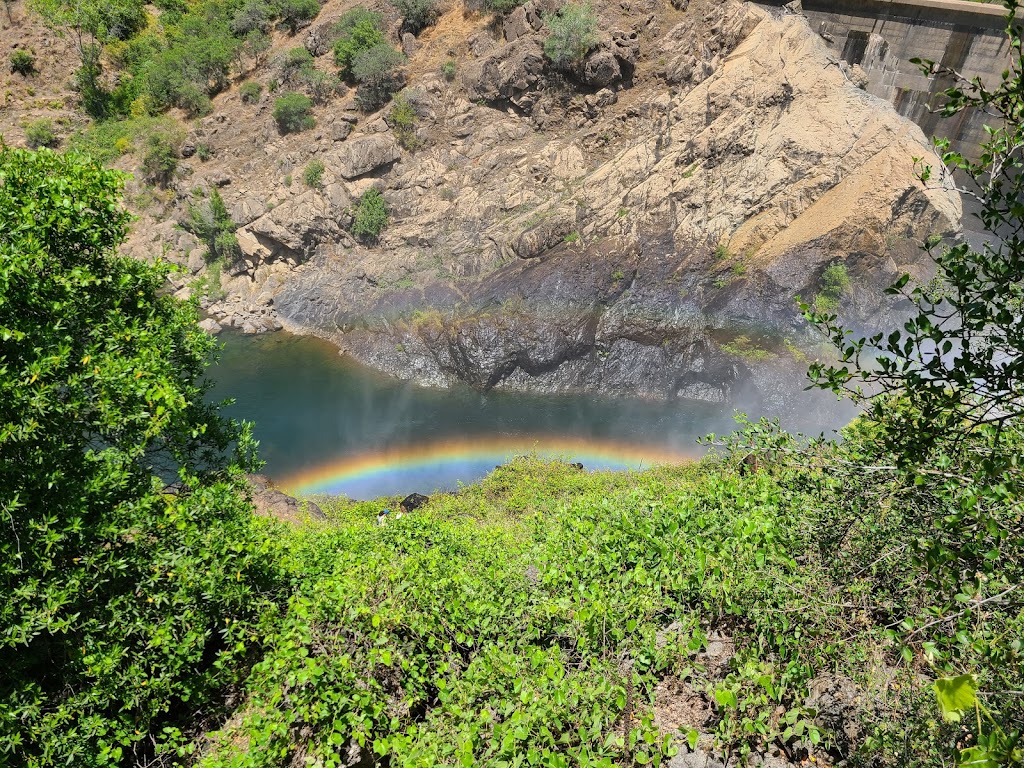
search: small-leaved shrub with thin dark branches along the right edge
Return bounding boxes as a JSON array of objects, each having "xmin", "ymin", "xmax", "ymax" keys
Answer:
[{"xmin": 802, "ymin": 6, "xmax": 1024, "ymax": 766}]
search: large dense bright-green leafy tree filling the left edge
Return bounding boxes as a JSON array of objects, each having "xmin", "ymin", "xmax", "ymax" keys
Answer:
[{"xmin": 0, "ymin": 148, "xmax": 278, "ymax": 768}]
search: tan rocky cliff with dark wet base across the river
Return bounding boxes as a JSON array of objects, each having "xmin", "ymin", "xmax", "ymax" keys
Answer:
[{"xmin": 112, "ymin": 0, "xmax": 961, "ymax": 400}]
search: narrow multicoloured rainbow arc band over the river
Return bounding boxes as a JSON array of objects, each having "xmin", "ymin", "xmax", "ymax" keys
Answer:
[{"xmin": 278, "ymin": 436, "xmax": 694, "ymax": 494}]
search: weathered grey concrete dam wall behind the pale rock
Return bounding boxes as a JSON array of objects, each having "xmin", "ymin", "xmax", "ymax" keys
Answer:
[{"xmin": 760, "ymin": 0, "xmax": 1011, "ymax": 157}]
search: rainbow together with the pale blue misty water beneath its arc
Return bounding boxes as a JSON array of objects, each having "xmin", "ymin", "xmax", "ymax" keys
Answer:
[{"xmin": 276, "ymin": 436, "xmax": 695, "ymax": 499}]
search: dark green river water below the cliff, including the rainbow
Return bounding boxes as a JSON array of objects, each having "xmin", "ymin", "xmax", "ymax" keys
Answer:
[{"xmin": 203, "ymin": 332, "xmax": 843, "ymax": 499}]
